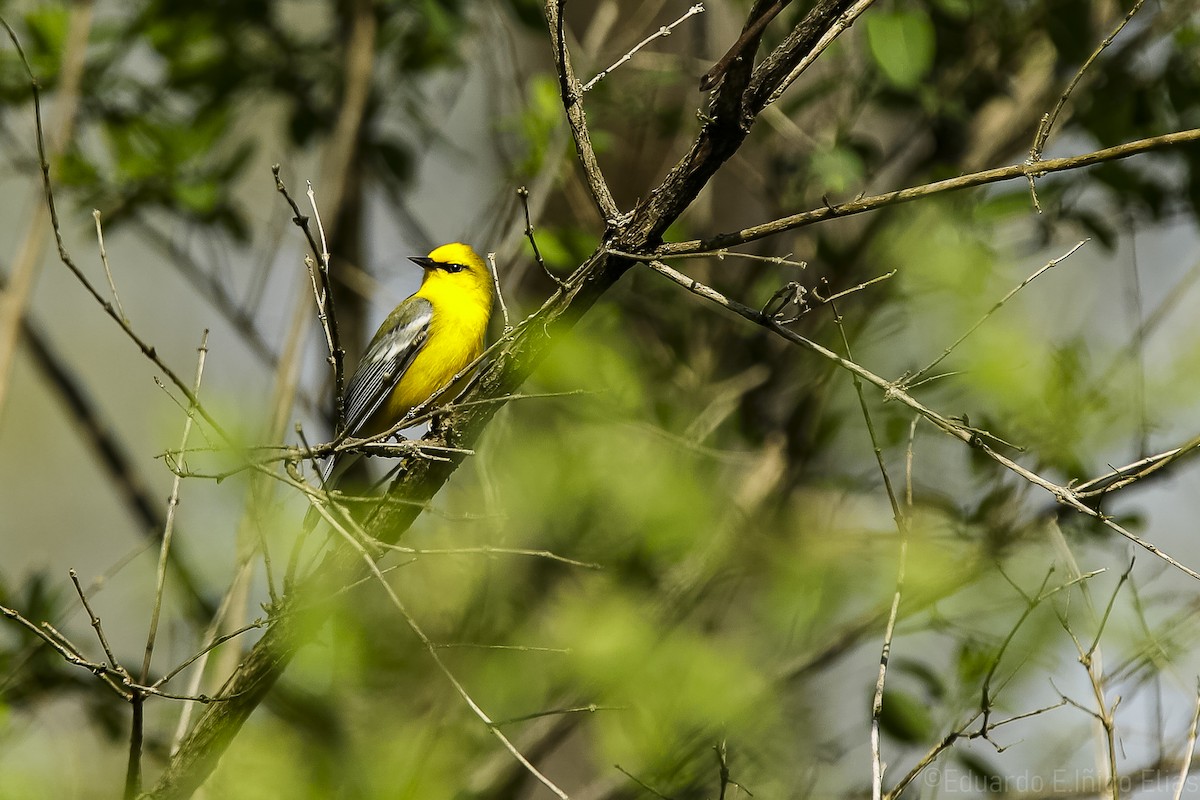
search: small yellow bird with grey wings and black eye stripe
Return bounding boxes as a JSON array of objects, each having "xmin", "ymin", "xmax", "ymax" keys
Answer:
[{"xmin": 322, "ymin": 242, "xmax": 493, "ymax": 489}]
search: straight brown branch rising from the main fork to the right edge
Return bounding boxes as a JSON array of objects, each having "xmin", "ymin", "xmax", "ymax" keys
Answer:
[{"xmin": 654, "ymin": 128, "xmax": 1200, "ymax": 259}]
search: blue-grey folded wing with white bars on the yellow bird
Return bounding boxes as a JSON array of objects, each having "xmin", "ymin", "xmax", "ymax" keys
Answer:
[{"xmin": 346, "ymin": 297, "xmax": 433, "ymax": 435}]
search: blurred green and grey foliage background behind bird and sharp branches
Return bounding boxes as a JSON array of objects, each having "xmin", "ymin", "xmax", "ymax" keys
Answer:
[{"xmin": 0, "ymin": 0, "xmax": 1200, "ymax": 799}]
